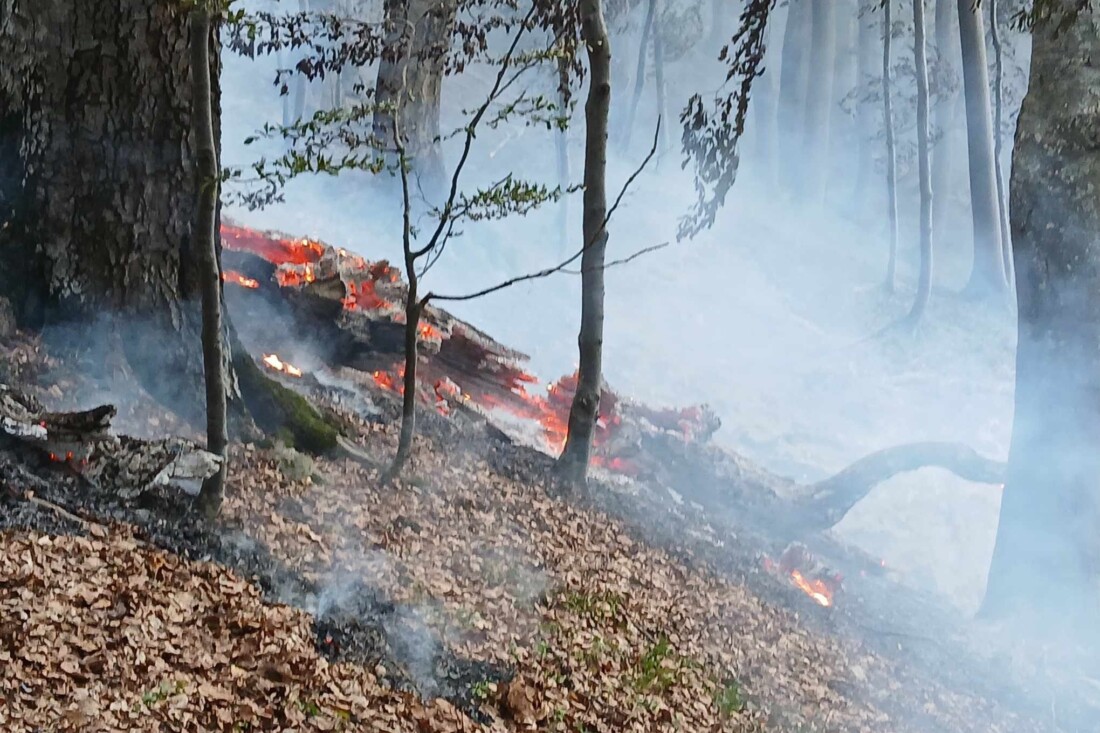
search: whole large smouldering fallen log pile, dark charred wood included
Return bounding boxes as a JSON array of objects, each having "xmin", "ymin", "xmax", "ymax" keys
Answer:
[{"xmin": 222, "ymin": 223, "xmax": 721, "ymax": 475}]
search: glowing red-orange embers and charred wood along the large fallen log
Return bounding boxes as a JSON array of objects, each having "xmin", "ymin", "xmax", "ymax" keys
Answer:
[{"xmin": 216, "ymin": 225, "xmax": 717, "ymax": 475}]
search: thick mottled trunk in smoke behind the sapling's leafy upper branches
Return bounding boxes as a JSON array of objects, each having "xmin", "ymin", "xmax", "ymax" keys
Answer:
[{"xmin": 374, "ymin": 0, "xmax": 457, "ymax": 193}]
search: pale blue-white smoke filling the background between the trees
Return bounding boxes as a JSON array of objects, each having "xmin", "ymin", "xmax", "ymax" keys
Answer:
[{"xmin": 222, "ymin": 0, "xmax": 1030, "ymax": 611}]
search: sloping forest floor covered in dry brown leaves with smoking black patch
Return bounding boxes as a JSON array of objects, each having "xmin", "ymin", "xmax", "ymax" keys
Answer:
[{"xmin": 0, "ymin": 325, "xmax": 1091, "ymax": 733}]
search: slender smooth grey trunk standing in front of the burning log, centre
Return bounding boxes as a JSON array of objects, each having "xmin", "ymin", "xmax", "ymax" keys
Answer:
[{"xmin": 559, "ymin": 0, "xmax": 612, "ymax": 483}]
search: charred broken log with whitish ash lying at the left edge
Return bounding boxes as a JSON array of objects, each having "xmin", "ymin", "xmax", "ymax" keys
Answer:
[{"xmin": 0, "ymin": 384, "xmax": 221, "ymax": 499}]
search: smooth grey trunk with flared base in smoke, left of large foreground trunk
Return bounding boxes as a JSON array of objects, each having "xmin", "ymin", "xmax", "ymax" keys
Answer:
[{"xmin": 958, "ymin": 0, "xmax": 1008, "ymax": 295}]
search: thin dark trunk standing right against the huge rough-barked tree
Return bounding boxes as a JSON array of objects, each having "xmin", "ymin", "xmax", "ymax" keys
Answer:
[{"xmin": 190, "ymin": 4, "xmax": 229, "ymax": 517}]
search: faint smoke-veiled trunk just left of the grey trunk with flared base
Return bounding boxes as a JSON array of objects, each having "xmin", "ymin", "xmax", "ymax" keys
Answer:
[{"xmin": 932, "ymin": 0, "xmax": 963, "ymax": 243}]
